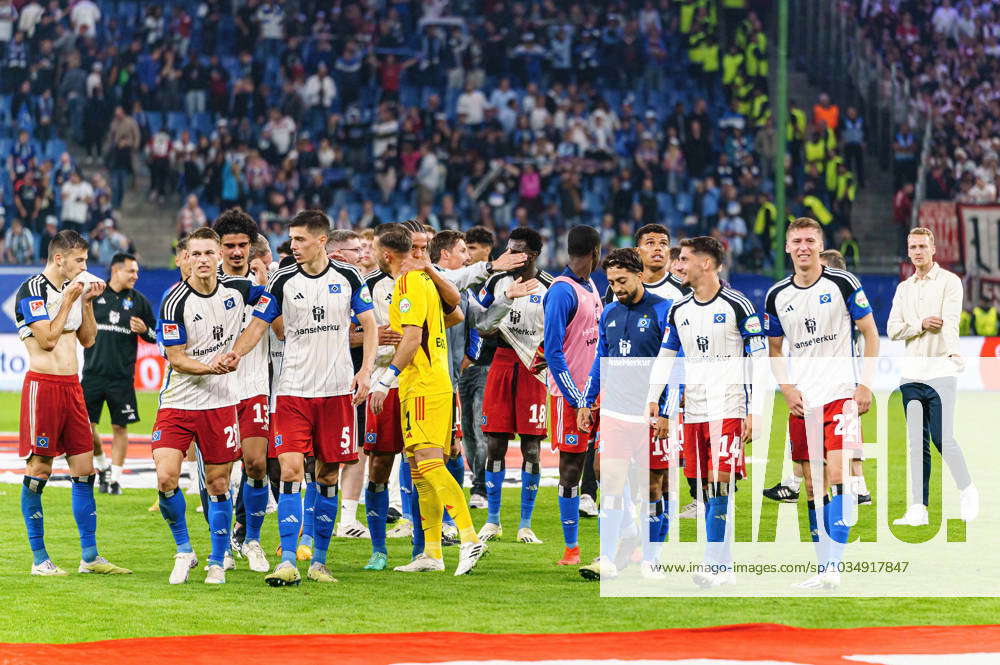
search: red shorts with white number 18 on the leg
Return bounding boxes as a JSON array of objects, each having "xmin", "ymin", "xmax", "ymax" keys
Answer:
[{"xmin": 482, "ymin": 349, "xmax": 547, "ymax": 436}]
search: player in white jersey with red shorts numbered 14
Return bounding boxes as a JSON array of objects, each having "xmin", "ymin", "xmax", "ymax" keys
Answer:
[{"xmin": 649, "ymin": 236, "xmax": 766, "ymax": 587}]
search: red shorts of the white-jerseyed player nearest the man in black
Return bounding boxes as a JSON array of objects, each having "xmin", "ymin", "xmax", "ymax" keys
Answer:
[{"xmin": 152, "ymin": 405, "xmax": 243, "ymax": 464}]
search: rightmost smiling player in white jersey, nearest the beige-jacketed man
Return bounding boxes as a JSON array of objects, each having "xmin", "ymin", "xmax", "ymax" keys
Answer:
[{"xmin": 764, "ymin": 217, "xmax": 879, "ymax": 589}]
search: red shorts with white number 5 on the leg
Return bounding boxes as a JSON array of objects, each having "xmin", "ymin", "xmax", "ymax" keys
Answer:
[{"xmin": 274, "ymin": 395, "xmax": 358, "ymax": 463}]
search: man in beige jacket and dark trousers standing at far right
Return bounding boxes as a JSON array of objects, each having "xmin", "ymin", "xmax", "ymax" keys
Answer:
[{"xmin": 888, "ymin": 227, "xmax": 979, "ymax": 526}]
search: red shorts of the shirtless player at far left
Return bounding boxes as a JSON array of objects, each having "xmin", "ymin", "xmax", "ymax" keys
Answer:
[{"xmin": 18, "ymin": 371, "xmax": 94, "ymax": 457}]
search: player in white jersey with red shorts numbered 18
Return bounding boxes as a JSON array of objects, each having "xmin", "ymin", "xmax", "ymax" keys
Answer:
[{"xmin": 476, "ymin": 227, "xmax": 553, "ymax": 544}]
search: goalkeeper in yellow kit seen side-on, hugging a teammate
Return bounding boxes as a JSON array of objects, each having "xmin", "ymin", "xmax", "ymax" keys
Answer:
[{"xmin": 370, "ymin": 220, "xmax": 486, "ymax": 575}]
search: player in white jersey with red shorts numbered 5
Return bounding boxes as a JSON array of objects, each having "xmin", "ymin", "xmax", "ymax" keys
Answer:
[{"xmin": 227, "ymin": 210, "xmax": 378, "ymax": 587}]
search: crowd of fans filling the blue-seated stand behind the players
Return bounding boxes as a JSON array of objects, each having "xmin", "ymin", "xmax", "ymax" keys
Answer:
[{"xmin": 0, "ymin": 0, "xmax": 864, "ymax": 270}]
